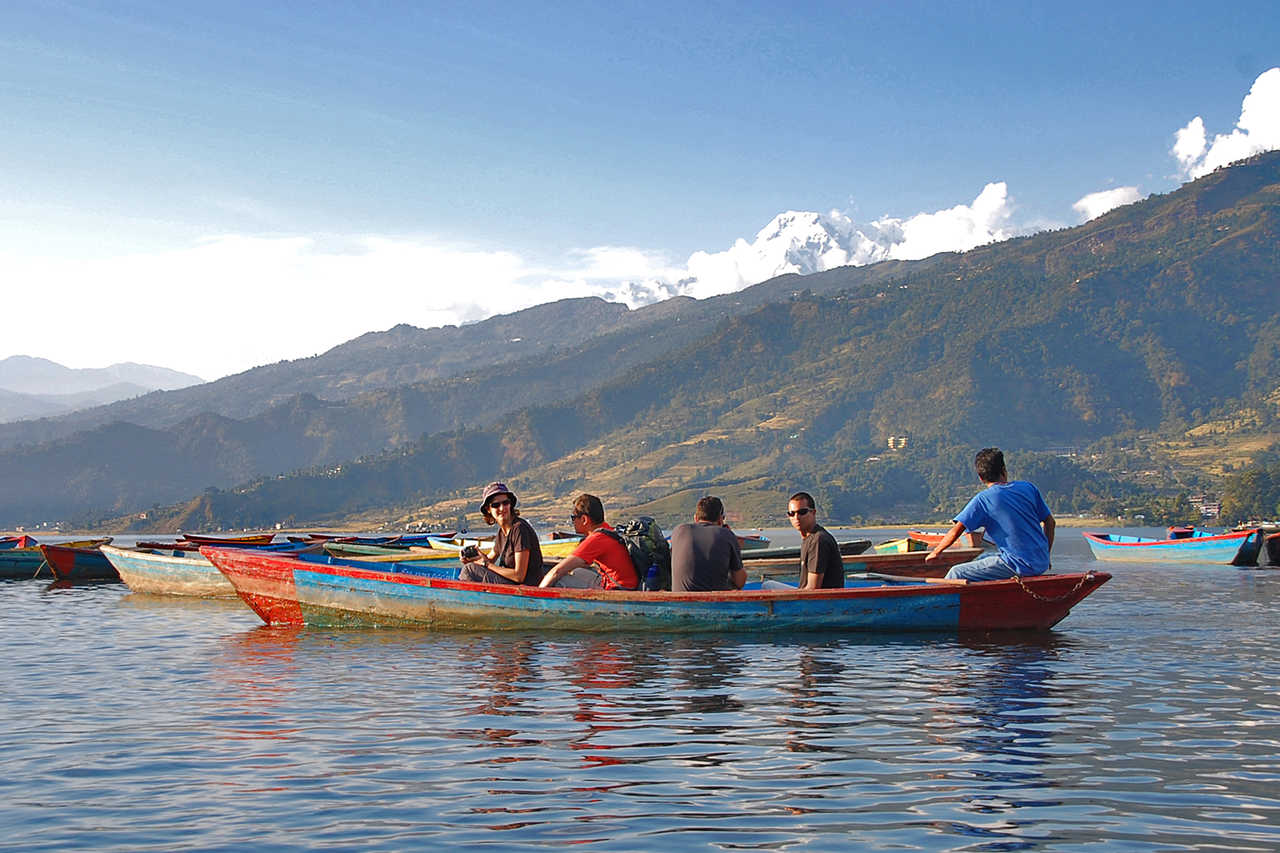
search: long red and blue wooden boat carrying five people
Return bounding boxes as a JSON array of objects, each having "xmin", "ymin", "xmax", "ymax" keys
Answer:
[{"xmin": 201, "ymin": 547, "xmax": 1111, "ymax": 633}]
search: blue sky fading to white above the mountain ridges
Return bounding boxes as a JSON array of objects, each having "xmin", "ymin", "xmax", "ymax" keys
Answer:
[{"xmin": 0, "ymin": 0, "xmax": 1280, "ymax": 378}]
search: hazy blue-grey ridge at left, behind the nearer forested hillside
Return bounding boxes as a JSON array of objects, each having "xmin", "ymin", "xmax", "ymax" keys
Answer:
[{"xmin": 0, "ymin": 261, "xmax": 931, "ymax": 525}]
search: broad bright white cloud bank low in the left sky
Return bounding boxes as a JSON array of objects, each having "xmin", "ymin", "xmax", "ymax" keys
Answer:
[{"xmin": 0, "ymin": 234, "xmax": 563, "ymax": 379}]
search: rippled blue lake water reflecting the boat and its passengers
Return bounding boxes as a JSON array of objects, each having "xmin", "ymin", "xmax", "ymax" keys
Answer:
[{"xmin": 0, "ymin": 529, "xmax": 1280, "ymax": 850}]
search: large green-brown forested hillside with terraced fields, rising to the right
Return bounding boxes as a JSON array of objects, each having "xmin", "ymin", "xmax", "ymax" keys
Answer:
[{"xmin": 102, "ymin": 148, "xmax": 1280, "ymax": 526}]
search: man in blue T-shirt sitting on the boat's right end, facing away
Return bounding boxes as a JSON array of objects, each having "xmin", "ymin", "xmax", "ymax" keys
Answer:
[{"xmin": 924, "ymin": 447, "xmax": 1057, "ymax": 580}]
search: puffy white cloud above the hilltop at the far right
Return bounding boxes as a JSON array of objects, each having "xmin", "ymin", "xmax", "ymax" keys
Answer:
[{"xmin": 1170, "ymin": 68, "xmax": 1280, "ymax": 178}]
